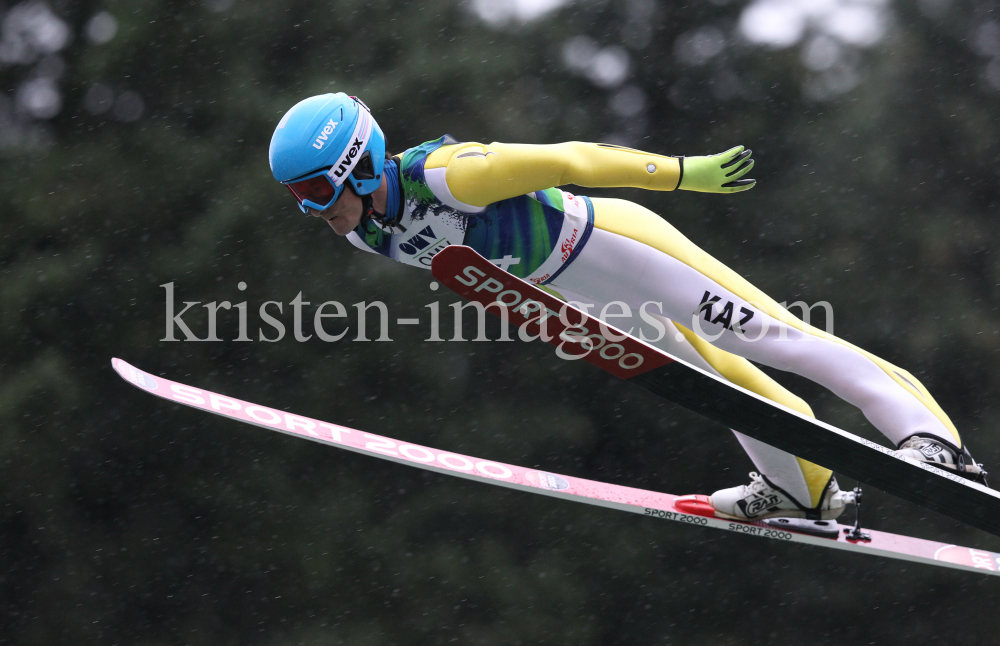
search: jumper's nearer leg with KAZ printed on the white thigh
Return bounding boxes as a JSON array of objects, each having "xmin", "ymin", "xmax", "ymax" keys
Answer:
[{"xmin": 554, "ymin": 199, "xmax": 961, "ymax": 496}]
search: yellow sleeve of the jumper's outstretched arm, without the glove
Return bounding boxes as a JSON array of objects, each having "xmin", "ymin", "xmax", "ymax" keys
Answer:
[{"xmin": 424, "ymin": 141, "xmax": 681, "ymax": 206}]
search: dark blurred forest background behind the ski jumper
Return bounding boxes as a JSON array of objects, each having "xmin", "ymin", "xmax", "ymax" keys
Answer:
[{"xmin": 0, "ymin": 0, "xmax": 1000, "ymax": 645}]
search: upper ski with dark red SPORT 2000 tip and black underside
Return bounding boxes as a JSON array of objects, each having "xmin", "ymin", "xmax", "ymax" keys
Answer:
[{"xmin": 431, "ymin": 245, "xmax": 1000, "ymax": 536}]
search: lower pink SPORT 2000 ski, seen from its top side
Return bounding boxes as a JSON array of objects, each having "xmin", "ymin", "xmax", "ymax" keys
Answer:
[{"xmin": 111, "ymin": 358, "xmax": 1000, "ymax": 575}]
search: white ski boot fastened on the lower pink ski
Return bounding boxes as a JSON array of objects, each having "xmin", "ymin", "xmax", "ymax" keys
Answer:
[{"xmin": 708, "ymin": 472, "xmax": 854, "ymax": 520}]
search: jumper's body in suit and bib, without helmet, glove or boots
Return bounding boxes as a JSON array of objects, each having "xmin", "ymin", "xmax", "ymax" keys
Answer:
[{"xmin": 348, "ymin": 136, "xmax": 961, "ymax": 508}]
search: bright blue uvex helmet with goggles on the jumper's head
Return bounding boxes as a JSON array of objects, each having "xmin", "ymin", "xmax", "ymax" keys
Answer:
[{"xmin": 268, "ymin": 92, "xmax": 385, "ymax": 213}]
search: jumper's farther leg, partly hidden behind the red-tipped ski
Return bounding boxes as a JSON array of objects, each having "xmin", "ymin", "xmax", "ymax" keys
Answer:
[{"xmin": 559, "ymin": 288, "xmax": 831, "ymax": 508}]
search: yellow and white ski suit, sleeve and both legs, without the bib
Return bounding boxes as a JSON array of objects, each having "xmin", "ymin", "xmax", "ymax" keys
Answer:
[{"xmin": 366, "ymin": 142, "xmax": 961, "ymax": 507}]
